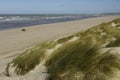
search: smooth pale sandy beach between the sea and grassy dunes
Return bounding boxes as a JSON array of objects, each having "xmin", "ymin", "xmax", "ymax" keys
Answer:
[{"xmin": 0, "ymin": 15, "xmax": 120, "ymax": 73}]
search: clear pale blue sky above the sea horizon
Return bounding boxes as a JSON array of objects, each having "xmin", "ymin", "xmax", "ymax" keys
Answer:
[{"xmin": 0, "ymin": 0, "xmax": 120, "ymax": 14}]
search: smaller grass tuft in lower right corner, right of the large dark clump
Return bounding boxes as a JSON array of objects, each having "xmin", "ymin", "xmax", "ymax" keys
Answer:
[{"xmin": 83, "ymin": 52, "xmax": 120, "ymax": 80}]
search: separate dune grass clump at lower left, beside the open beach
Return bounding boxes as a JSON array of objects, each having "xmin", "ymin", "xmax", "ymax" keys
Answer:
[{"xmin": 6, "ymin": 42, "xmax": 56, "ymax": 75}]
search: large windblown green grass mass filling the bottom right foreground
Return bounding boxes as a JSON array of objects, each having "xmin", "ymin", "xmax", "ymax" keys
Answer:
[{"xmin": 46, "ymin": 39, "xmax": 120, "ymax": 80}]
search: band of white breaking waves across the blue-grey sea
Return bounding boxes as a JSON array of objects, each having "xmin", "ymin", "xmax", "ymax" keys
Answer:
[{"xmin": 0, "ymin": 16, "xmax": 82, "ymax": 22}]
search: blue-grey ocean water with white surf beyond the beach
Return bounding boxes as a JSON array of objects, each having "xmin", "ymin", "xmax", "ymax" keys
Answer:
[{"xmin": 0, "ymin": 14, "xmax": 100, "ymax": 30}]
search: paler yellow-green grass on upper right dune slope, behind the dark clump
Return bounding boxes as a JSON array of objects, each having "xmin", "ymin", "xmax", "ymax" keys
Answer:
[{"xmin": 80, "ymin": 19, "xmax": 120, "ymax": 45}]
